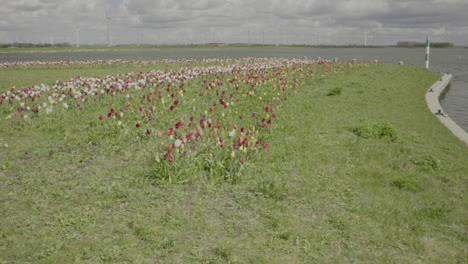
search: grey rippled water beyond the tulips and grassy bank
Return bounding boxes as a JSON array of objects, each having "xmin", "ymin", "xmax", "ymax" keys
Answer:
[{"xmin": 0, "ymin": 48, "xmax": 468, "ymax": 131}]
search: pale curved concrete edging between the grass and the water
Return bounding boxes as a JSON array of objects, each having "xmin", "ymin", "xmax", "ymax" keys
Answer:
[{"xmin": 426, "ymin": 73, "xmax": 468, "ymax": 145}]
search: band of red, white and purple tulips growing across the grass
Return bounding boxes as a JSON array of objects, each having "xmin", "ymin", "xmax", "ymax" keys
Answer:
[{"xmin": 0, "ymin": 58, "xmax": 352, "ymax": 182}]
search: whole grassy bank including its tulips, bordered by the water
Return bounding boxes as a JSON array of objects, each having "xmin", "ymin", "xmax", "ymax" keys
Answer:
[{"xmin": 0, "ymin": 57, "xmax": 468, "ymax": 263}]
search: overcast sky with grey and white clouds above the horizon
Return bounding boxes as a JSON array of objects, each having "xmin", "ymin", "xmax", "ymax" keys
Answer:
[{"xmin": 0, "ymin": 0, "xmax": 468, "ymax": 45}]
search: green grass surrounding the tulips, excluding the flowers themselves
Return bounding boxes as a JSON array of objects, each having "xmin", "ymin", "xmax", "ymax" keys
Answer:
[{"xmin": 0, "ymin": 60, "xmax": 468, "ymax": 263}]
